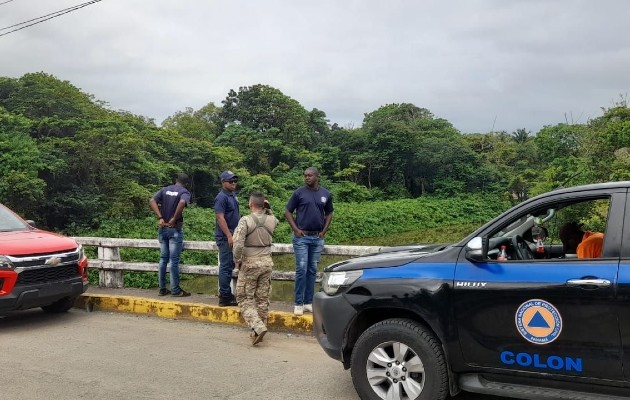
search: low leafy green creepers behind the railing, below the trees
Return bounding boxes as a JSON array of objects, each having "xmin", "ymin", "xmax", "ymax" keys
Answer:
[{"xmin": 82, "ymin": 194, "xmax": 508, "ymax": 280}]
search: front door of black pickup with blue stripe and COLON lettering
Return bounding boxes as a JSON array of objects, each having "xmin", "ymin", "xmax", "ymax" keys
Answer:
[{"xmin": 453, "ymin": 189, "xmax": 630, "ymax": 380}]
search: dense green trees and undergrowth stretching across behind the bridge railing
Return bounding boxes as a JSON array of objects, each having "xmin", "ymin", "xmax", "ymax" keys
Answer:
[{"xmin": 0, "ymin": 73, "xmax": 630, "ymax": 239}]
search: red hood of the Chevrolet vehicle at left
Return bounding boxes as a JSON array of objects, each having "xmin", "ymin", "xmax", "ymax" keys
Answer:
[{"xmin": 0, "ymin": 229, "xmax": 78, "ymax": 256}]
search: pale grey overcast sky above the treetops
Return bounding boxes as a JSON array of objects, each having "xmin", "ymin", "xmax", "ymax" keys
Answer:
[{"xmin": 0, "ymin": 0, "xmax": 630, "ymax": 133}]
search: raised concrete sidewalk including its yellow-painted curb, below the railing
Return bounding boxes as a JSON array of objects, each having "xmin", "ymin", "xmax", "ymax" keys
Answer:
[{"xmin": 75, "ymin": 286, "xmax": 313, "ymax": 334}]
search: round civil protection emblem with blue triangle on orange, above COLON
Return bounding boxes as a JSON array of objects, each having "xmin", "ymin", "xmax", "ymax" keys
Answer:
[{"xmin": 515, "ymin": 299, "xmax": 562, "ymax": 344}]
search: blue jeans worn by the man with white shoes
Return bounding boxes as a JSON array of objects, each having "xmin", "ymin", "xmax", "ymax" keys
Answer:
[{"xmin": 293, "ymin": 235, "xmax": 324, "ymax": 306}]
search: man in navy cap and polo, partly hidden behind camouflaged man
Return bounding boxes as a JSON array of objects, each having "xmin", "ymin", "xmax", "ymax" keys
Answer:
[{"xmin": 214, "ymin": 171, "xmax": 241, "ymax": 307}]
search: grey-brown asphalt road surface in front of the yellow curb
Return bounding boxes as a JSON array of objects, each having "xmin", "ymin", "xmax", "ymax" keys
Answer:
[{"xmin": 0, "ymin": 309, "xmax": 508, "ymax": 400}]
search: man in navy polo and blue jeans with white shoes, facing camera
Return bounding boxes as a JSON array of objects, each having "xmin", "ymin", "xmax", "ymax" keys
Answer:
[{"xmin": 284, "ymin": 167, "xmax": 333, "ymax": 315}]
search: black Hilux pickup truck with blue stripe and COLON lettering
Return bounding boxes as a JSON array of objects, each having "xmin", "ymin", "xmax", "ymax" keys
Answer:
[{"xmin": 313, "ymin": 182, "xmax": 630, "ymax": 400}]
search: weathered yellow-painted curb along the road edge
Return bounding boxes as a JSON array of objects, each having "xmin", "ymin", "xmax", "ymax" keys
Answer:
[{"xmin": 75, "ymin": 293, "xmax": 313, "ymax": 334}]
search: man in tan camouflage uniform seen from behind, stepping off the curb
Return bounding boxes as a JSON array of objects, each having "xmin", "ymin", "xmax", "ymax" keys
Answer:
[{"xmin": 233, "ymin": 191, "xmax": 278, "ymax": 345}]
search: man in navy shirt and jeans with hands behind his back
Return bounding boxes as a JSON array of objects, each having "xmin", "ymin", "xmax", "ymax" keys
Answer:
[{"xmin": 149, "ymin": 173, "xmax": 190, "ymax": 297}]
